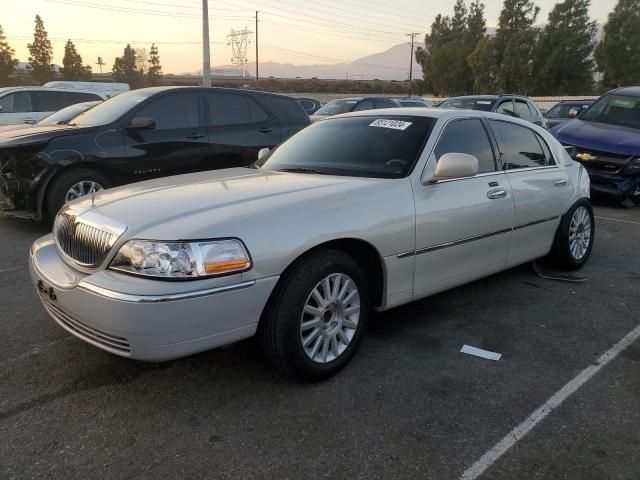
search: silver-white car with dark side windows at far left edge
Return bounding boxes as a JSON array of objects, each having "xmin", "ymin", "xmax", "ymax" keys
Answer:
[{"xmin": 0, "ymin": 87, "xmax": 107, "ymax": 125}]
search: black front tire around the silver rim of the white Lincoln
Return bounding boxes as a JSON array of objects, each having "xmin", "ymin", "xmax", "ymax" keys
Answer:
[{"xmin": 258, "ymin": 249, "xmax": 371, "ymax": 382}]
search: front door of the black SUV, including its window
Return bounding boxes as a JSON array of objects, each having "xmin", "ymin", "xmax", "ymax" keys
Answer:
[{"xmin": 120, "ymin": 91, "xmax": 209, "ymax": 181}]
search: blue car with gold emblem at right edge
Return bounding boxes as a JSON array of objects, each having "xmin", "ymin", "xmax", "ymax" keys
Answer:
[{"xmin": 551, "ymin": 87, "xmax": 640, "ymax": 208}]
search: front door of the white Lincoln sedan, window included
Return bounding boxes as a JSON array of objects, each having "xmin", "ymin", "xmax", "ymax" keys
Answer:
[{"xmin": 414, "ymin": 118, "xmax": 514, "ymax": 298}]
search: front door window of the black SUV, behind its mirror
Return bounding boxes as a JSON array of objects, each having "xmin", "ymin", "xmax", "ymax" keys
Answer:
[{"xmin": 138, "ymin": 93, "xmax": 200, "ymax": 130}]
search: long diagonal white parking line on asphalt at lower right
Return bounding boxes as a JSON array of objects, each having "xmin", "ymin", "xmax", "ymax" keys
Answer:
[{"xmin": 460, "ymin": 325, "xmax": 640, "ymax": 480}]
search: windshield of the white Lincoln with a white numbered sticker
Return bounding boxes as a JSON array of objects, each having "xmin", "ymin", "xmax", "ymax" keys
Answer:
[{"xmin": 257, "ymin": 115, "xmax": 435, "ymax": 178}]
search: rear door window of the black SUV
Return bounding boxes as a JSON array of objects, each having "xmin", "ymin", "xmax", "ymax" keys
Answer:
[{"xmin": 205, "ymin": 93, "xmax": 269, "ymax": 127}]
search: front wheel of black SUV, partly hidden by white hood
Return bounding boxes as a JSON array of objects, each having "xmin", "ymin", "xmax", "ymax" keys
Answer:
[{"xmin": 45, "ymin": 168, "xmax": 112, "ymax": 220}]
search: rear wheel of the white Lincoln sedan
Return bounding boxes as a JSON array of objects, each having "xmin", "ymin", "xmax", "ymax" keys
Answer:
[{"xmin": 549, "ymin": 198, "xmax": 595, "ymax": 270}]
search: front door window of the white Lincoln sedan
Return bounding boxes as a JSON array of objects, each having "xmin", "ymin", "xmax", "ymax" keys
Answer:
[{"xmin": 435, "ymin": 118, "xmax": 496, "ymax": 173}]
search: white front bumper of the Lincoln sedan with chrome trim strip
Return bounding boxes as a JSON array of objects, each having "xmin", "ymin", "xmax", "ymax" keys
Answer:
[{"xmin": 29, "ymin": 235, "xmax": 278, "ymax": 361}]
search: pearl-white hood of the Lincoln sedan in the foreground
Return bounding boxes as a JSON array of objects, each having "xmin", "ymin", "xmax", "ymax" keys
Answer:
[{"xmin": 69, "ymin": 168, "xmax": 385, "ymax": 239}]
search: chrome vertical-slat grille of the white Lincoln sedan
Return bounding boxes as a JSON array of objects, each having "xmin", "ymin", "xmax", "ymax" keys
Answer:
[{"xmin": 54, "ymin": 211, "xmax": 122, "ymax": 268}]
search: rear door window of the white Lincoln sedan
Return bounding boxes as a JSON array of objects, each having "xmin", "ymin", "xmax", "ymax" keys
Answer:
[{"xmin": 491, "ymin": 120, "xmax": 548, "ymax": 170}]
